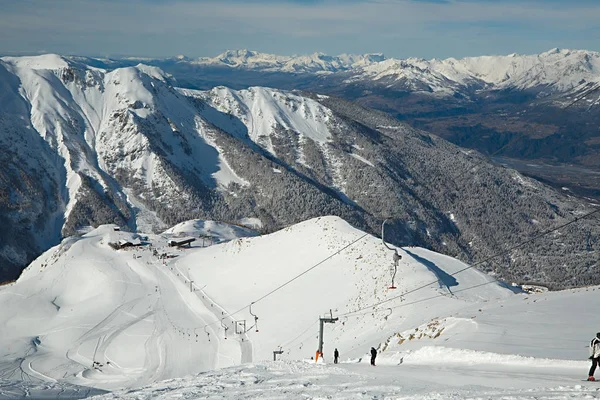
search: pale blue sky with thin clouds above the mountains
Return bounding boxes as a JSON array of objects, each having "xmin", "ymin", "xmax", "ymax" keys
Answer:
[{"xmin": 0, "ymin": 0, "xmax": 600, "ymax": 58}]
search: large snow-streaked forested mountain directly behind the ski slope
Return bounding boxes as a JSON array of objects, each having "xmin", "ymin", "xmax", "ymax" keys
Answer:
[{"xmin": 0, "ymin": 55, "xmax": 600, "ymax": 287}]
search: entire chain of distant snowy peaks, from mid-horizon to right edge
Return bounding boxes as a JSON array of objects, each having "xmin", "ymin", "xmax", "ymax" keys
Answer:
[{"xmin": 193, "ymin": 49, "xmax": 600, "ymax": 95}]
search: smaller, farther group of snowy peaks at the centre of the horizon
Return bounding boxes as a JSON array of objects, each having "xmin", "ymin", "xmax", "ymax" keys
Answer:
[{"xmin": 194, "ymin": 49, "xmax": 385, "ymax": 73}]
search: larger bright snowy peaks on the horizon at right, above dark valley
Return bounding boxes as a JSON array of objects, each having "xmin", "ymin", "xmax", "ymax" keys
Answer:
[{"xmin": 349, "ymin": 49, "xmax": 600, "ymax": 92}]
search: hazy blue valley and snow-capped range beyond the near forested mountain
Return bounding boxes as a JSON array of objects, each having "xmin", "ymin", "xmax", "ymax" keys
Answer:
[{"xmin": 77, "ymin": 49, "xmax": 600, "ymax": 199}]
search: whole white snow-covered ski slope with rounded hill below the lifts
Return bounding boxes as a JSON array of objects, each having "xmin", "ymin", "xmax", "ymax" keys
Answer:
[{"xmin": 0, "ymin": 217, "xmax": 600, "ymax": 400}]
